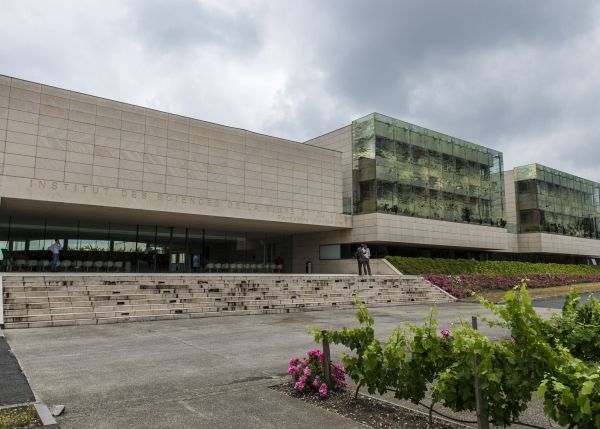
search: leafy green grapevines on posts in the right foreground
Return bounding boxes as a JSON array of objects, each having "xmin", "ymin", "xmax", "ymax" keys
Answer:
[{"xmin": 312, "ymin": 290, "xmax": 600, "ymax": 429}]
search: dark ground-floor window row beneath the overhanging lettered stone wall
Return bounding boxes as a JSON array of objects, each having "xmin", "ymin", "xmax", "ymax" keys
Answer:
[{"xmin": 0, "ymin": 216, "xmax": 291, "ymax": 272}]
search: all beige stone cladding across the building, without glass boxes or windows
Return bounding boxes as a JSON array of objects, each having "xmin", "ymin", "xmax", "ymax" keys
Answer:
[{"xmin": 0, "ymin": 71, "xmax": 600, "ymax": 274}]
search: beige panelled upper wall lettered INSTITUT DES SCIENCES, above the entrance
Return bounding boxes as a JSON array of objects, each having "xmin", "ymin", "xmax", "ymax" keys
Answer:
[{"xmin": 0, "ymin": 76, "xmax": 351, "ymax": 231}]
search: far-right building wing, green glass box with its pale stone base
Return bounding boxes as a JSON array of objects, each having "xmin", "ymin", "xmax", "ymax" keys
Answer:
[{"xmin": 505, "ymin": 164, "xmax": 600, "ymax": 263}]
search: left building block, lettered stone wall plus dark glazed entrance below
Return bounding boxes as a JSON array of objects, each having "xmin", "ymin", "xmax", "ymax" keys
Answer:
[{"xmin": 0, "ymin": 77, "xmax": 352, "ymax": 272}]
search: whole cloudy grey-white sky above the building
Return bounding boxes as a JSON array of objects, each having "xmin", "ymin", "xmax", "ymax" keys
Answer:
[{"xmin": 0, "ymin": 0, "xmax": 600, "ymax": 181}]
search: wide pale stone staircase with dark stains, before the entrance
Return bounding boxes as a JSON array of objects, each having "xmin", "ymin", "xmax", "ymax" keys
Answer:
[{"xmin": 2, "ymin": 274, "xmax": 453, "ymax": 328}]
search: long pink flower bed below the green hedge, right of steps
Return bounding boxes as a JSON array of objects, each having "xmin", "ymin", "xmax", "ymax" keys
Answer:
[{"xmin": 422, "ymin": 274, "xmax": 600, "ymax": 299}]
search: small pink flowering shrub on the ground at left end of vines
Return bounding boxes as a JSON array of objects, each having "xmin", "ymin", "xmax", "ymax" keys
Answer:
[{"xmin": 288, "ymin": 349, "xmax": 346, "ymax": 398}]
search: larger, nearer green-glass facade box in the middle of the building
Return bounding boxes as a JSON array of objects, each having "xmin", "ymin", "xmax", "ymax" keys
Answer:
[{"xmin": 352, "ymin": 113, "xmax": 506, "ymax": 227}]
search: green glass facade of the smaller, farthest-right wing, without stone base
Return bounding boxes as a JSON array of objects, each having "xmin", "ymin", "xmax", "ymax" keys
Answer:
[{"xmin": 513, "ymin": 164, "xmax": 600, "ymax": 239}]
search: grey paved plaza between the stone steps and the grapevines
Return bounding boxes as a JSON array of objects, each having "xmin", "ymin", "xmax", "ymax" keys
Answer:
[{"xmin": 4, "ymin": 303, "xmax": 546, "ymax": 429}]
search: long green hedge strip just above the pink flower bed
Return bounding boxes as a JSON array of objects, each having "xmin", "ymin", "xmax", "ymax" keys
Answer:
[{"xmin": 386, "ymin": 256, "xmax": 600, "ymax": 275}]
